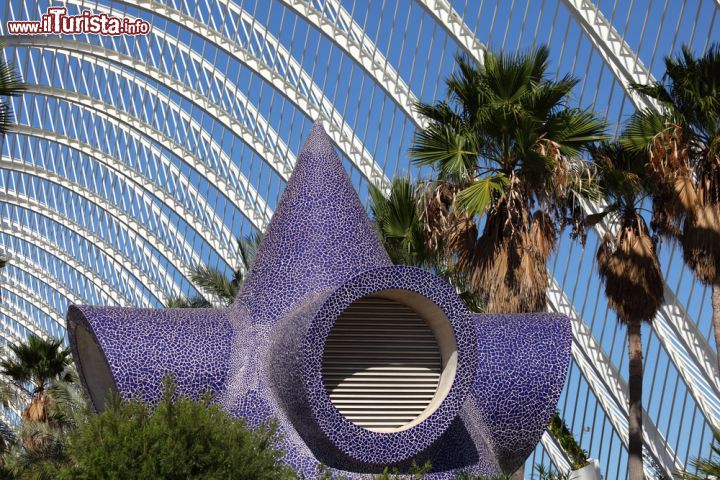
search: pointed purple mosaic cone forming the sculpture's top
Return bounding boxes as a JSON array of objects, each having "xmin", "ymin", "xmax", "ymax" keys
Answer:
[{"xmin": 236, "ymin": 121, "xmax": 390, "ymax": 321}]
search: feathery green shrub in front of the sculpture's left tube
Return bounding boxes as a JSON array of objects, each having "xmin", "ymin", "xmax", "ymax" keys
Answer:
[{"xmin": 51, "ymin": 386, "xmax": 297, "ymax": 480}]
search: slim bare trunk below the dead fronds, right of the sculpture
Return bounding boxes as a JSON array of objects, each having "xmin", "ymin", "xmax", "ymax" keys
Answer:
[{"xmin": 628, "ymin": 322, "xmax": 645, "ymax": 480}]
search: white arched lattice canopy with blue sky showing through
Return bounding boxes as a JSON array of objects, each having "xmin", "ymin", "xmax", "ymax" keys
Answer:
[{"xmin": 0, "ymin": 0, "xmax": 720, "ymax": 478}]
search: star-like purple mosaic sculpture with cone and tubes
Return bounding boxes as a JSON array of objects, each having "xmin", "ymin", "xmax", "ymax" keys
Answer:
[{"xmin": 67, "ymin": 123, "xmax": 571, "ymax": 479}]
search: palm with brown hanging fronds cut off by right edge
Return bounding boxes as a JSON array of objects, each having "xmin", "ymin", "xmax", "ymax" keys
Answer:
[{"xmin": 623, "ymin": 45, "xmax": 720, "ymax": 361}]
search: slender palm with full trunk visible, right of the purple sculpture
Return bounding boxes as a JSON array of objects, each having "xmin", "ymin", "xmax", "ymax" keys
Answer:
[{"xmin": 592, "ymin": 143, "xmax": 663, "ymax": 480}]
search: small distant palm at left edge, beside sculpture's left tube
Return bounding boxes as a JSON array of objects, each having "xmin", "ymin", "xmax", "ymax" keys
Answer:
[{"xmin": 0, "ymin": 334, "xmax": 74, "ymax": 422}]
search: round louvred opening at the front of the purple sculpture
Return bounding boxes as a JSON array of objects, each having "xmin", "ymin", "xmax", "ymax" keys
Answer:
[{"xmin": 323, "ymin": 290, "xmax": 457, "ymax": 432}]
